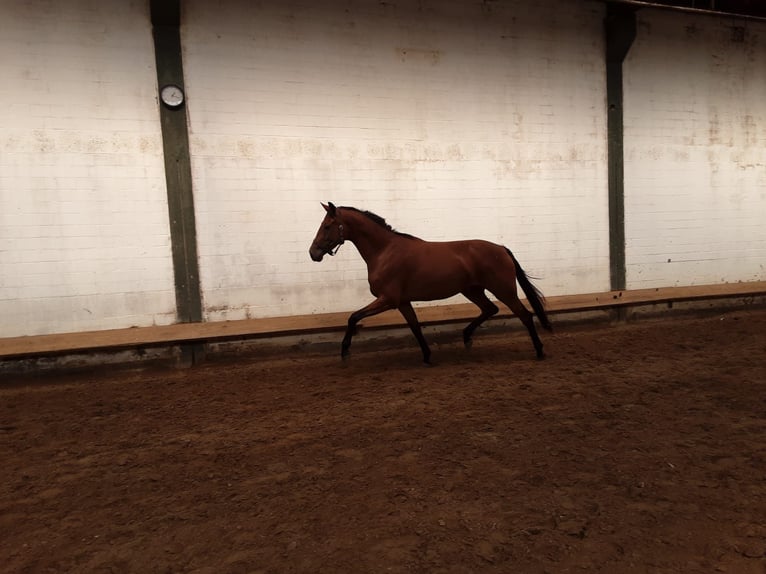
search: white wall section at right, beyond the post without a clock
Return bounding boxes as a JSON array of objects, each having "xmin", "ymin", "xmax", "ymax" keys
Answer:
[{"xmin": 624, "ymin": 10, "xmax": 766, "ymax": 288}]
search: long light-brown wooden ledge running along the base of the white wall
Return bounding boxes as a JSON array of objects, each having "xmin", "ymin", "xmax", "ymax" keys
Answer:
[{"xmin": 0, "ymin": 281, "xmax": 766, "ymax": 359}]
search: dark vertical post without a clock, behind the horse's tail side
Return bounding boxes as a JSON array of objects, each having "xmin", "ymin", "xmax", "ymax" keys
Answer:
[{"xmin": 606, "ymin": 4, "xmax": 636, "ymax": 290}]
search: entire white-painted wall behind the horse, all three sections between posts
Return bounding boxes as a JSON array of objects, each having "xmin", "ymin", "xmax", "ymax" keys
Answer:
[{"xmin": 0, "ymin": 0, "xmax": 766, "ymax": 337}]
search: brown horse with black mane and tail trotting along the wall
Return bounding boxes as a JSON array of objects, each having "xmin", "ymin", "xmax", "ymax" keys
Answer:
[{"xmin": 309, "ymin": 203, "xmax": 551, "ymax": 363}]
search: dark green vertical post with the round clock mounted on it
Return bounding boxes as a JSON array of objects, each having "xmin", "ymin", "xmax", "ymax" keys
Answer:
[{"xmin": 151, "ymin": 0, "xmax": 204, "ymax": 364}]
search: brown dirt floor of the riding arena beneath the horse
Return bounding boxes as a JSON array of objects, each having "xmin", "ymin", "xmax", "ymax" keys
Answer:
[{"xmin": 0, "ymin": 309, "xmax": 766, "ymax": 574}]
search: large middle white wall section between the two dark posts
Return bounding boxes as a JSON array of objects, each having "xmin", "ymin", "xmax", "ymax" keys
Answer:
[{"xmin": 182, "ymin": 0, "xmax": 609, "ymax": 320}]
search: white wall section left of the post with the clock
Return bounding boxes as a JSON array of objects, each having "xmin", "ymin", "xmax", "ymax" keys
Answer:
[{"xmin": 0, "ymin": 0, "xmax": 175, "ymax": 337}]
